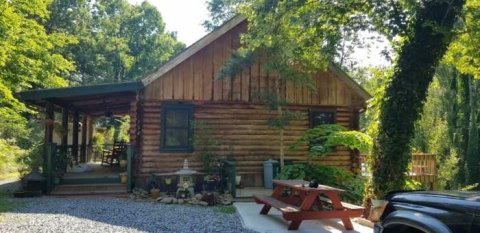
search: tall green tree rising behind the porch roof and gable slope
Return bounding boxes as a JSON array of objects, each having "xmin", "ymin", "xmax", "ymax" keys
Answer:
[{"xmin": 46, "ymin": 0, "xmax": 184, "ymax": 84}]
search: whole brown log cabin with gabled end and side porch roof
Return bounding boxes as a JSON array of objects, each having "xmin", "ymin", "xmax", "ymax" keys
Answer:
[{"xmin": 19, "ymin": 16, "xmax": 371, "ymax": 192}]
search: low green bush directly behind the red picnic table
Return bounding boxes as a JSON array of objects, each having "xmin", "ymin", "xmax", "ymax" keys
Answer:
[{"xmin": 277, "ymin": 163, "xmax": 365, "ymax": 204}]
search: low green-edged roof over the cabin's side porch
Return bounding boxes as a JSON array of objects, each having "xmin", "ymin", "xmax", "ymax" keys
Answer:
[{"xmin": 17, "ymin": 81, "xmax": 144, "ymax": 116}]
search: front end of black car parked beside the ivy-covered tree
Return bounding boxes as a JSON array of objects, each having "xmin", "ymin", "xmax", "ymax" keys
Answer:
[{"xmin": 374, "ymin": 191, "xmax": 480, "ymax": 233}]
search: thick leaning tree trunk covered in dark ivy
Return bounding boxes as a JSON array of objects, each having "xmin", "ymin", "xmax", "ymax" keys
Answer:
[{"xmin": 372, "ymin": 0, "xmax": 464, "ymax": 196}]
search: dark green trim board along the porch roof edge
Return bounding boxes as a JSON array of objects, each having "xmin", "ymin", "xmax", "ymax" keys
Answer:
[{"xmin": 17, "ymin": 81, "xmax": 144, "ymax": 101}]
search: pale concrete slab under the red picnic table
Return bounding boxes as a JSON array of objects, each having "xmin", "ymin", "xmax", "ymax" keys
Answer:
[{"xmin": 234, "ymin": 202, "xmax": 373, "ymax": 233}]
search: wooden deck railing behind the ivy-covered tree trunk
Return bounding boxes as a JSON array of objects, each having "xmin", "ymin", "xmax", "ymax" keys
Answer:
[{"xmin": 360, "ymin": 153, "xmax": 437, "ymax": 189}]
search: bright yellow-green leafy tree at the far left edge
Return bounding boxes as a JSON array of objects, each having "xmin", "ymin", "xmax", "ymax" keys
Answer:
[{"xmin": 0, "ymin": 0, "xmax": 75, "ymax": 142}]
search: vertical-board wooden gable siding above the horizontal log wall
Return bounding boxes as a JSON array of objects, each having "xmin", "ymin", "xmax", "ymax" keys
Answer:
[{"xmin": 143, "ymin": 16, "xmax": 371, "ymax": 104}]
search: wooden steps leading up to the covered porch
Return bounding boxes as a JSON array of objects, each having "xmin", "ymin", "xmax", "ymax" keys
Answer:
[{"xmin": 50, "ymin": 183, "xmax": 127, "ymax": 195}]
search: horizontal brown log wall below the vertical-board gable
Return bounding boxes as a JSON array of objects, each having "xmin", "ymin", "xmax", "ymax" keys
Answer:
[{"xmin": 137, "ymin": 100, "xmax": 352, "ymax": 186}]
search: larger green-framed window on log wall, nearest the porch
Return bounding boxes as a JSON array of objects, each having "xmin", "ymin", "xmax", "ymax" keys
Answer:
[{"xmin": 160, "ymin": 104, "xmax": 193, "ymax": 152}]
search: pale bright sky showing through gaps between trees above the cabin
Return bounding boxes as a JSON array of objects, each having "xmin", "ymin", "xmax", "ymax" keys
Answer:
[{"xmin": 128, "ymin": 0, "xmax": 389, "ymax": 66}]
